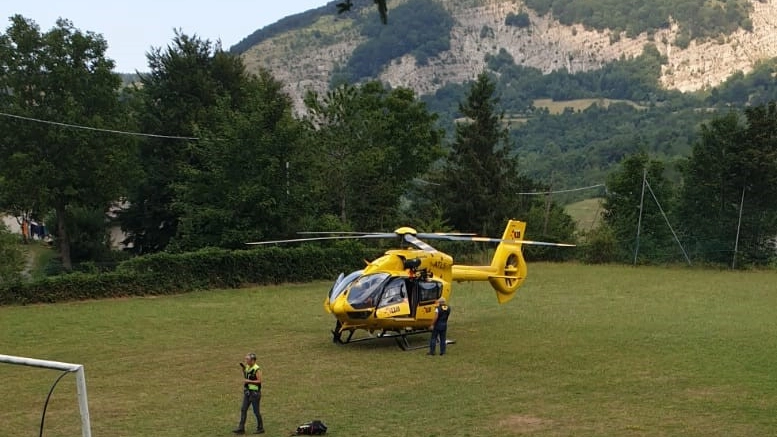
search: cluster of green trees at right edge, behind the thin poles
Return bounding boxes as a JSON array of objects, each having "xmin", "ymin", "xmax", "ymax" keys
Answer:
[{"xmin": 592, "ymin": 102, "xmax": 777, "ymax": 267}]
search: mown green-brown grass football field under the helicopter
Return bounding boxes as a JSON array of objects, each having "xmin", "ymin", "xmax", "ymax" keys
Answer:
[{"xmin": 0, "ymin": 264, "xmax": 777, "ymax": 437}]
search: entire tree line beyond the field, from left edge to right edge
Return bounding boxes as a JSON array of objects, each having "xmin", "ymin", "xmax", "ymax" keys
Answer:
[{"xmin": 0, "ymin": 16, "xmax": 777, "ymax": 282}]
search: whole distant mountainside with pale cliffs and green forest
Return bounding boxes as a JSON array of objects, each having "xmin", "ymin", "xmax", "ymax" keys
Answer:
[{"xmin": 233, "ymin": 0, "xmax": 777, "ymax": 198}]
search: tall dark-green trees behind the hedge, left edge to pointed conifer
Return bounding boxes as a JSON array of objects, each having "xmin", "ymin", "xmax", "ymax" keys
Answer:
[{"xmin": 0, "ymin": 16, "xmax": 573, "ymax": 278}]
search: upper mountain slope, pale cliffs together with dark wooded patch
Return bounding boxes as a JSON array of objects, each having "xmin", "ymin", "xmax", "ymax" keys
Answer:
[{"xmin": 232, "ymin": 0, "xmax": 777, "ymax": 96}]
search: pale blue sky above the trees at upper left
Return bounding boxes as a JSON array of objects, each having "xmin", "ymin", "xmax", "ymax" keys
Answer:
[{"xmin": 0, "ymin": 0, "xmax": 328, "ymax": 73}]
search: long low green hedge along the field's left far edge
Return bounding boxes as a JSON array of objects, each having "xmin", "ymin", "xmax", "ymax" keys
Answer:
[{"xmin": 0, "ymin": 244, "xmax": 377, "ymax": 305}]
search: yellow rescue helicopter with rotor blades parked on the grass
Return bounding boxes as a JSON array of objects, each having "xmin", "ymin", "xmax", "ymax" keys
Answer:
[{"xmin": 248, "ymin": 220, "xmax": 574, "ymax": 350}]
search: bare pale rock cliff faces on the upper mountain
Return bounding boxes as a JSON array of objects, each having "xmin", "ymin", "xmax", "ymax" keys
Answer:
[{"xmin": 243, "ymin": 0, "xmax": 777, "ymax": 112}]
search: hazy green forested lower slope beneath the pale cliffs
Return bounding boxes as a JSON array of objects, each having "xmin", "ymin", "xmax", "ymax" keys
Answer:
[{"xmin": 423, "ymin": 46, "xmax": 777, "ymax": 199}]
